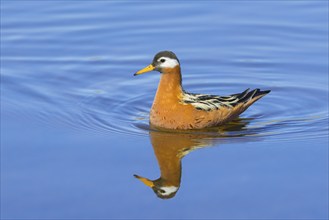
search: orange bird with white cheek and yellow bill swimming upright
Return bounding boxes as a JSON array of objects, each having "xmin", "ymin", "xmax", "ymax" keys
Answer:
[{"xmin": 134, "ymin": 51, "xmax": 271, "ymax": 130}]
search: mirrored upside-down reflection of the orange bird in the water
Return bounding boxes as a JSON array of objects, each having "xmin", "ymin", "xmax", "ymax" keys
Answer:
[{"xmin": 134, "ymin": 119, "xmax": 248, "ymax": 199}]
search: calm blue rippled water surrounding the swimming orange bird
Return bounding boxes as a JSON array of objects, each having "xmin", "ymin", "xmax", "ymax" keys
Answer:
[{"xmin": 1, "ymin": 0, "xmax": 329, "ymax": 219}]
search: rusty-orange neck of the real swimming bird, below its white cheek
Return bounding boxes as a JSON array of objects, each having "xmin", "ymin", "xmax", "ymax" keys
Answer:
[{"xmin": 156, "ymin": 65, "xmax": 183, "ymax": 100}]
